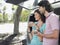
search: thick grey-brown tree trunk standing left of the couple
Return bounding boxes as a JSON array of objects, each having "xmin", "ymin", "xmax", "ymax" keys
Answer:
[{"xmin": 14, "ymin": 6, "xmax": 22, "ymax": 34}]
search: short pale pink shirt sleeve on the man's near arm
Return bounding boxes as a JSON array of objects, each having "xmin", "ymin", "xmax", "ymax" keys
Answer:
[{"xmin": 50, "ymin": 16, "xmax": 59, "ymax": 30}]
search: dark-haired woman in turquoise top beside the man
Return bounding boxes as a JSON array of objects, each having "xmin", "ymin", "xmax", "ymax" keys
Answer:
[{"xmin": 29, "ymin": 10, "xmax": 45, "ymax": 45}]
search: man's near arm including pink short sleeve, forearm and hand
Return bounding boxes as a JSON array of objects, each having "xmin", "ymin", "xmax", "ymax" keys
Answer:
[{"xmin": 40, "ymin": 16, "xmax": 59, "ymax": 39}]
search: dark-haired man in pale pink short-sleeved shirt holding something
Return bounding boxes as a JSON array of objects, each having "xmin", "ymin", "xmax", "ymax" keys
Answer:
[{"xmin": 37, "ymin": 1, "xmax": 59, "ymax": 45}]
